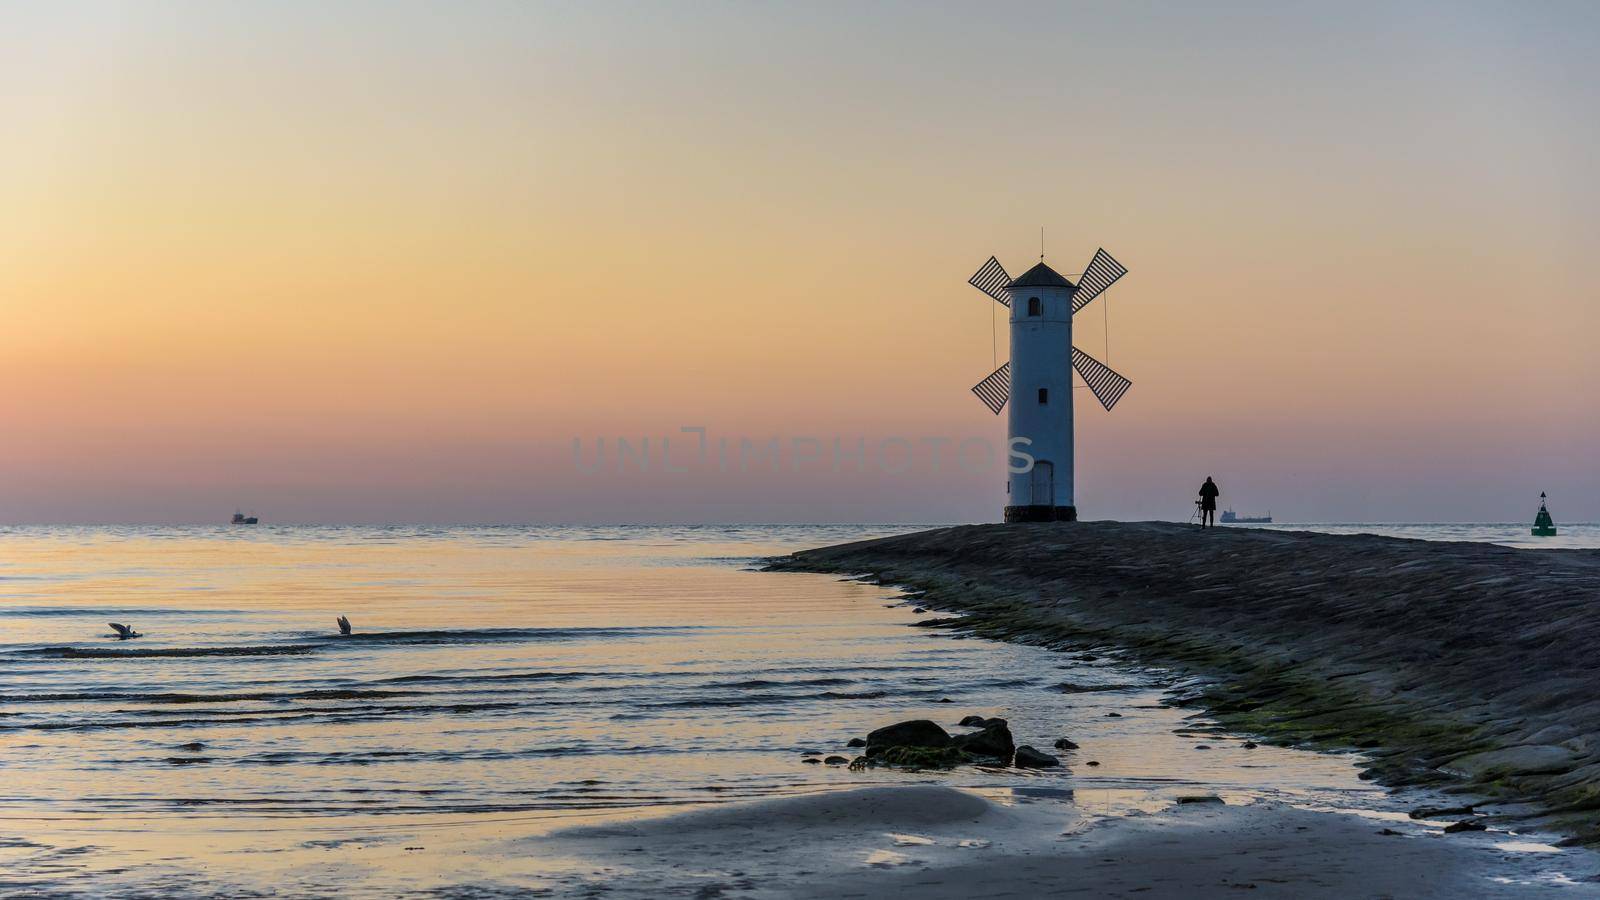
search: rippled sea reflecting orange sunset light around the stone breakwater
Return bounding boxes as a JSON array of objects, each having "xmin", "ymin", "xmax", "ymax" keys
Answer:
[{"xmin": 0, "ymin": 524, "xmax": 1600, "ymax": 897}]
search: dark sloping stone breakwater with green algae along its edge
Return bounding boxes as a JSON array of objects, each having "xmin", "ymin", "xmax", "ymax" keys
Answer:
[{"xmin": 771, "ymin": 522, "xmax": 1600, "ymax": 842}]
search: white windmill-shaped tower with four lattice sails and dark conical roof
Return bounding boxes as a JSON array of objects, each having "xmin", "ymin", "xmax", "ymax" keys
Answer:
[{"xmin": 971, "ymin": 250, "xmax": 1133, "ymax": 522}]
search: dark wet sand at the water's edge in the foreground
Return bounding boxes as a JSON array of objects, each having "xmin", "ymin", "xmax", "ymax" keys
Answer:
[{"xmin": 550, "ymin": 786, "xmax": 1592, "ymax": 898}]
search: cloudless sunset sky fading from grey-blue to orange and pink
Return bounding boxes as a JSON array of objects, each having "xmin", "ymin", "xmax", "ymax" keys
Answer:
[{"xmin": 0, "ymin": 2, "xmax": 1600, "ymax": 524}]
